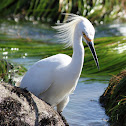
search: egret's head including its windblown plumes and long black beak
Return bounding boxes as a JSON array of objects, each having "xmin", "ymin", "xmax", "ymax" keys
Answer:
[{"xmin": 53, "ymin": 14, "xmax": 99, "ymax": 69}]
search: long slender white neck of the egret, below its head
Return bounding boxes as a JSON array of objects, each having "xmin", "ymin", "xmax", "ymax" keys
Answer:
[{"xmin": 70, "ymin": 30, "xmax": 84, "ymax": 79}]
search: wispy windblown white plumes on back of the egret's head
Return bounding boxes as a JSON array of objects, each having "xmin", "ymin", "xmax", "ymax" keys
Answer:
[{"xmin": 53, "ymin": 13, "xmax": 84, "ymax": 48}]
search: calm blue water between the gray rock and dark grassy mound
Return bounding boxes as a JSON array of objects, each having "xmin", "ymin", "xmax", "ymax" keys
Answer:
[{"xmin": 63, "ymin": 78, "xmax": 108, "ymax": 126}]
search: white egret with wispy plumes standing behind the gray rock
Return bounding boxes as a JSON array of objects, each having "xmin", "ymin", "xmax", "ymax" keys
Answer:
[{"xmin": 20, "ymin": 14, "xmax": 99, "ymax": 113}]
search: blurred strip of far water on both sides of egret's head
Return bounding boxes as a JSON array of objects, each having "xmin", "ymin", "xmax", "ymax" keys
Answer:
[{"xmin": 0, "ymin": 22, "xmax": 126, "ymax": 42}]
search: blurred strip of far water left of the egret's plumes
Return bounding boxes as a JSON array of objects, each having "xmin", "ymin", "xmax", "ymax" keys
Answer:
[{"xmin": 0, "ymin": 22, "xmax": 55, "ymax": 42}]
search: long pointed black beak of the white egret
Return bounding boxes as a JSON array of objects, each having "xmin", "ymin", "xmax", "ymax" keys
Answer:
[{"xmin": 87, "ymin": 42, "xmax": 100, "ymax": 70}]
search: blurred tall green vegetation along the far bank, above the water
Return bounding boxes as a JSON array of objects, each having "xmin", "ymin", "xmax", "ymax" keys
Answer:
[{"xmin": 0, "ymin": 0, "xmax": 126, "ymax": 24}]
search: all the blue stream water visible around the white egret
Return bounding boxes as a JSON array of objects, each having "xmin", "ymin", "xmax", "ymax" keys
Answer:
[{"xmin": 0, "ymin": 22, "xmax": 126, "ymax": 126}]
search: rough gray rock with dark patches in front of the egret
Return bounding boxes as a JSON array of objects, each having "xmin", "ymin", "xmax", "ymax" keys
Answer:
[{"xmin": 0, "ymin": 83, "xmax": 68, "ymax": 126}]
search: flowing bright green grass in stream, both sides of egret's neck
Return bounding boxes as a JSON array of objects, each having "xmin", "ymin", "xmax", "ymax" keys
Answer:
[{"xmin": 0, "ymin": 34, "xmax": 126, "ymax": 77}]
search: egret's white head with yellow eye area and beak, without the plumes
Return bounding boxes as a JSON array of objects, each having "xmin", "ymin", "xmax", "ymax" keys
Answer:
[{"xmin": 79, "ymin": 18, "xmax": 99, "ymax": 70}]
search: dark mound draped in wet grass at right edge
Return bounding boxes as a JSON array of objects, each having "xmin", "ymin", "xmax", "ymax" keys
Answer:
[{"xmin": 100, "ymin": 70, "xmax": 126, "ymax": 126}]
